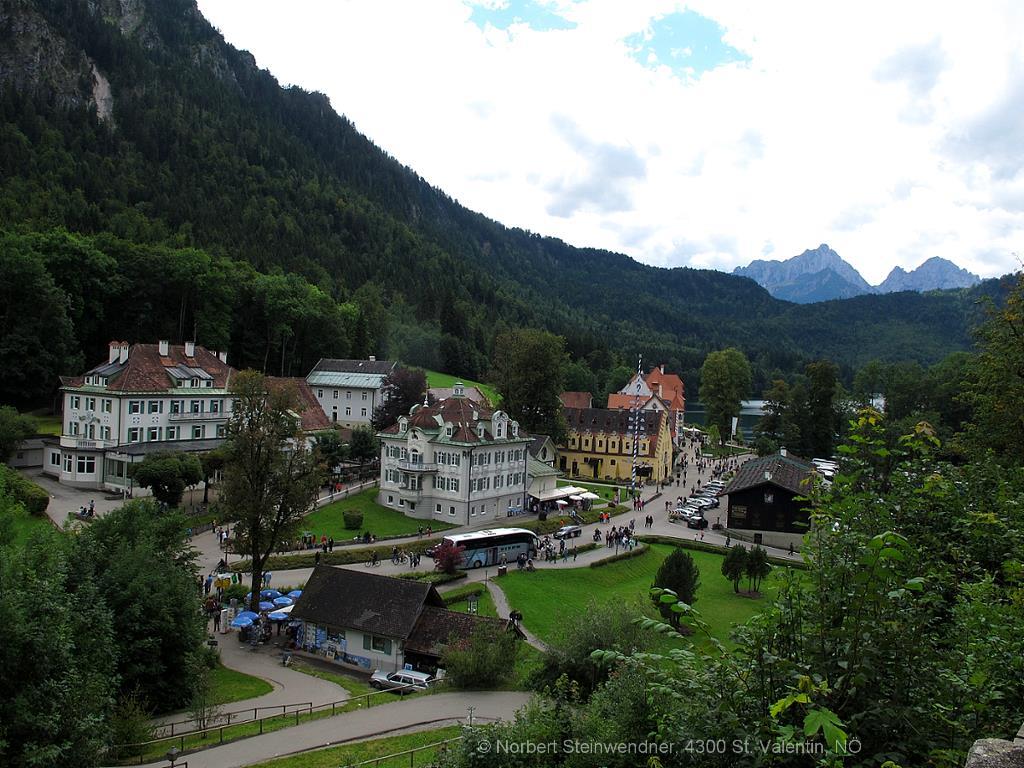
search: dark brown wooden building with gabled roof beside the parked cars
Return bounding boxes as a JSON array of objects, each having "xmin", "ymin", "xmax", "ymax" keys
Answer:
[{"xmin": 722, "ymin": 451, "xmax": 815, "ymax": 547}]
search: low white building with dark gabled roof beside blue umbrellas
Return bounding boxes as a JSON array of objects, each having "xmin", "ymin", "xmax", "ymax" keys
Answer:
[{"xmin": 292, "ymin": 565, "xmax": 505, "ymax": 672}]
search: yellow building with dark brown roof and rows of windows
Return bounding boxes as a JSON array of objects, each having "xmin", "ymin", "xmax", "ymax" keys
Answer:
[{"xmin": 558, "ymin": 408, "xmax": 672, "ymax": 482}]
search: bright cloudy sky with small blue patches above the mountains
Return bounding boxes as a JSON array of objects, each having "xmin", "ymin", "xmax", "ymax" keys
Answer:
[{"xmin": 193, "ymin": 0, "xmax": 1024, "ymax": 283}]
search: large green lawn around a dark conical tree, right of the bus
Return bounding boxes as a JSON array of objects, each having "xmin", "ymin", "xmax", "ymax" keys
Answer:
[{"xmin": 501, "ymin": 544, "xmax": 775, "ymax": 642}]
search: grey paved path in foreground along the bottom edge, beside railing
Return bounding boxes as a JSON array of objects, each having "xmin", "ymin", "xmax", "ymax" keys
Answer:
[{"xmin": 133, "ymin": 691, "xmax": 530, "ymax": 768}]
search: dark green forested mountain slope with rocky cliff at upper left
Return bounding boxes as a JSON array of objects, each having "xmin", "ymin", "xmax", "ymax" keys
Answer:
[{"xmin": 0, "ymin": 0, "xmax": 997, "ymax": 409}]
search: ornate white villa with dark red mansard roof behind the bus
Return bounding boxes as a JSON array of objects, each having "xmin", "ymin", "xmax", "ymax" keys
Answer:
[{"xmin": 378, "ymin": 383, "xmax": 531, "ymax": 524}]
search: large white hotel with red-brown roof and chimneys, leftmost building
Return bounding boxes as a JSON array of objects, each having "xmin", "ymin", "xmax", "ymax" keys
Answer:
[{"xmin": 43, "ymin": 341, "xmax": 236, "ymax": 492}]
